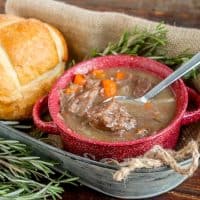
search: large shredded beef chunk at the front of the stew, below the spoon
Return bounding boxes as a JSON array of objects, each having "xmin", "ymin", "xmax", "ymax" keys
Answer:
[{"xmin": 87, "ymin": 100, "xmax": 136, "ymax": 132}]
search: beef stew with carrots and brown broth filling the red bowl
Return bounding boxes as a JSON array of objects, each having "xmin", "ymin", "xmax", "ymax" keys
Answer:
[{"xmin": 60, "ymin": 68, "xmax": 176, "ymax": 142}]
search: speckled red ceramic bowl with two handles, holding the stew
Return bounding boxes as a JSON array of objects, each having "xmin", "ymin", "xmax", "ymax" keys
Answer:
[{"xmin": 33, "ymin": 55, "xmax": 200, "ymax": 160}]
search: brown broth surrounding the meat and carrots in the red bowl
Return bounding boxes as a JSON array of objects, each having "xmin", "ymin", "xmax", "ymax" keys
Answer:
[{"xmin": 61, "ymin": 68, "xmax": 176, "ymax": 142}]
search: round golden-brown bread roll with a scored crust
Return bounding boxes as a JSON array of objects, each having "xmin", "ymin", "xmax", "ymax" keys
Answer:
[{"xmin": 0, "ymin": 15, "xmax": 68, "ymax": 120}]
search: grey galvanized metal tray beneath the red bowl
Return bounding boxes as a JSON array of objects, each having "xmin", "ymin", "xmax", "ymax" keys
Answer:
[{"xmin": 0, "ymin": 123, "xmax": 194, "ymax": 199}]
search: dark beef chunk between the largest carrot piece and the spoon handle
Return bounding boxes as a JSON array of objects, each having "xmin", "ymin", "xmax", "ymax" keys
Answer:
[{"xmin": 132, "ymin": 76, "xmax": 152, "ymax": 98}]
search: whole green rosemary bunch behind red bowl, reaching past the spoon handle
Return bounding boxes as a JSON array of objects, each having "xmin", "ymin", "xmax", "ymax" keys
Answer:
[{"xmin": 90, "ymin": 23, "xmax": 199, "ymax": 79}]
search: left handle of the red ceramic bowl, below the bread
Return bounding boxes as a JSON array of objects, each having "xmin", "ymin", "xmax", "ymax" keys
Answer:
[{"xmin": 33, "ymin": 96, "xmax": 59, "ymax": 135}]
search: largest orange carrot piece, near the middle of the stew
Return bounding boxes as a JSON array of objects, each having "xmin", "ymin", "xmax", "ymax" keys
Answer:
[{"xmin": 102, "ymin": 79, "xmax": 117, "ymax": 97}]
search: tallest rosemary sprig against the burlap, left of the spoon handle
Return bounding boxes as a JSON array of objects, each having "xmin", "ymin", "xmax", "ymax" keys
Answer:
[{"xmin": 91, "ymin": 23, "xmax": 167, "ymax": 57}]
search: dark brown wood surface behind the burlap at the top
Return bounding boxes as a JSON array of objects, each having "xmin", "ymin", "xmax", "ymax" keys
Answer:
[{"xmin": 57, "ymin": 0, "xmax": 200, "ymax": 28}]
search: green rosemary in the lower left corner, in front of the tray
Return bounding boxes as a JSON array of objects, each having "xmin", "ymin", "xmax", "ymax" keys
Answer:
[{"xmin": 0, "ymin": 138, "xmax": 78, "ymax": 200}]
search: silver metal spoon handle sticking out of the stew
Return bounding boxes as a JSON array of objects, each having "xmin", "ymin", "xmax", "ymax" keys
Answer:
[{"xmin": 142, "ymin": 52, "xmax": 200, "ymax": 100}]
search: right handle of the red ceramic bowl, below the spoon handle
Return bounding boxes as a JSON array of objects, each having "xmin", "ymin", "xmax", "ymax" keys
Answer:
[{"xmin": 182, "ymin": 87, "xmax": 200, "ymax": 125}]
